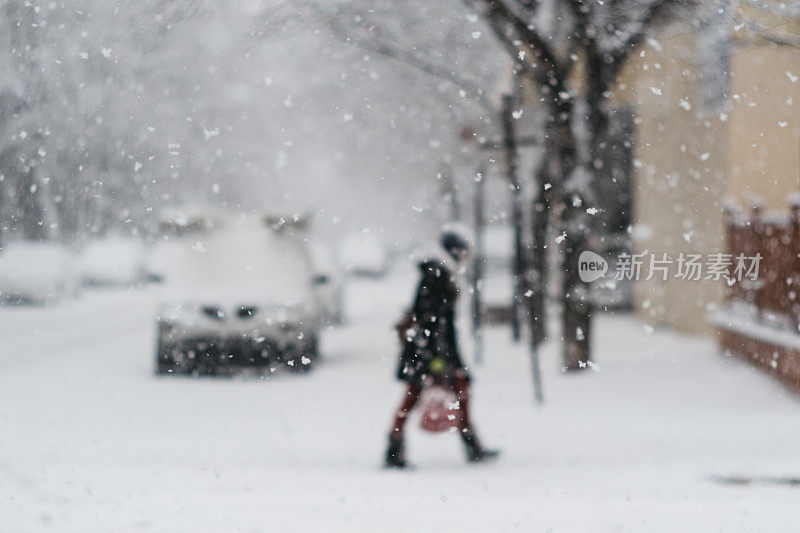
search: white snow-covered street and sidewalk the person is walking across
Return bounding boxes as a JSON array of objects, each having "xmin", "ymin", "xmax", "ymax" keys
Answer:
[{"xmin": 0, "ymin": 267, "xmax": 800, "ymax": 533}]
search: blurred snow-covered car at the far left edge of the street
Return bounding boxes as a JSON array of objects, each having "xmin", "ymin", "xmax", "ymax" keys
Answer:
[{"xmin": 0, "ymin": 241, "xmax": 78, "ymax": 305}]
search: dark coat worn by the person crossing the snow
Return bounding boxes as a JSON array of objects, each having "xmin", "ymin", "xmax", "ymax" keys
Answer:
[{"xmin": 397, "ymin": 259, "xmax": 467, "ymax": 383}]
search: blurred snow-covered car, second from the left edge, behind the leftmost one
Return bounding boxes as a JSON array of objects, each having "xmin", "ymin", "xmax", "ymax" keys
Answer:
[{"xmin": 80, "ymin": 237, "xmax": 147, "ymax": 287}]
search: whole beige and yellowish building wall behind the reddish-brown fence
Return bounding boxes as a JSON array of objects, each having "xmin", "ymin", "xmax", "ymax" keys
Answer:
[{"xmin": 618, "ymin": 19, "xmax": 800, "ymax": 334}]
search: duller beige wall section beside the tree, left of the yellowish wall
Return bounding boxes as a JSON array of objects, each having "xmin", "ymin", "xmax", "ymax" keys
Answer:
[{"xmin": 620, "ymin": 34, "xmax": 729, "ymax": 334}]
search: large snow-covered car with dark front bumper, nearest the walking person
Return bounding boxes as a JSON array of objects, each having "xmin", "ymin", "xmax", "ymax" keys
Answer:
[{"xmin": 156, "ymin": 217, "xmax": 321, "ymax": 374}]
